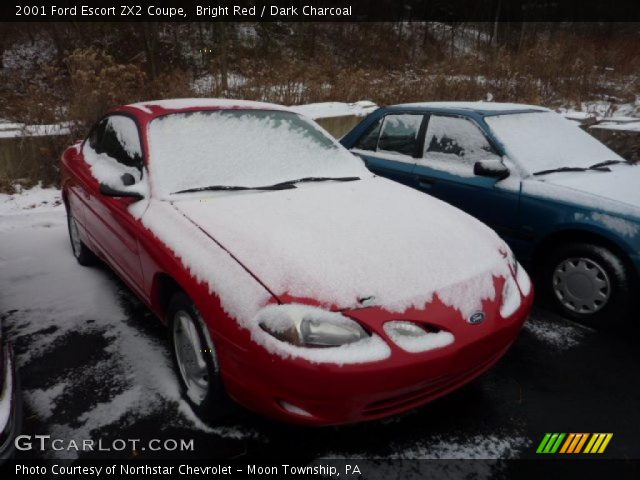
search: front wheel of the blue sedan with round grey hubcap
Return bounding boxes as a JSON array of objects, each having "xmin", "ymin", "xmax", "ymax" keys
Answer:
[{"xmin": 540, "ymin": 243, "xmax": 631, "ymax": 328}]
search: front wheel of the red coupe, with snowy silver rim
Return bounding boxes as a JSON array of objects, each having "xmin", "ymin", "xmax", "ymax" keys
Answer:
[{"xmin": 168, "ymin": 293, "xmax": 232, "ymax": 424}]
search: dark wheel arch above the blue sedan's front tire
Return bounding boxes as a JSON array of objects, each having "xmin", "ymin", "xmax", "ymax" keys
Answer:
[{"xmin": 531, "ymin": 230, "xmax": 640, "ymax": 282}]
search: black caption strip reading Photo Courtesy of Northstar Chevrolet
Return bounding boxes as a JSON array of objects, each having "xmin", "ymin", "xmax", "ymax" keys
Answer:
[{"xmin": 0, "ymin": 458, "xmax": 640, "ymax": 480}]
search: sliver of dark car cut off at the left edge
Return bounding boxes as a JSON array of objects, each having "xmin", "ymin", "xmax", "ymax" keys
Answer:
[{"xmin": 0, "ymin": 345, "xmax": 22, "ymax": 462}]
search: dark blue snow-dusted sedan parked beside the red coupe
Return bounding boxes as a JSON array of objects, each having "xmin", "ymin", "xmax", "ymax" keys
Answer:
[{"xmin": 341, "ymin": 102, "xmax": 640, "ymax": 326}]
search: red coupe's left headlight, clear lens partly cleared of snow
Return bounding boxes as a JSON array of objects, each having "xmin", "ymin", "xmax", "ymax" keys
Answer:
[{"xmin": 258, "ymin": 305, "xmax": 369, "ymax": 347}]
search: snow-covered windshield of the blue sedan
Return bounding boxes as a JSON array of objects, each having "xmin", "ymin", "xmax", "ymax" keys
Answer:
[{"xmin": 486, "ymin": 112, "xmax": 623, "ymax": 173}]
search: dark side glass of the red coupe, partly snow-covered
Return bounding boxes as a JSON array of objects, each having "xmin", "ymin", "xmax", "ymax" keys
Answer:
[{"xmin": 89, "ymin": 115, "xmax": 142, "ymax": 169}]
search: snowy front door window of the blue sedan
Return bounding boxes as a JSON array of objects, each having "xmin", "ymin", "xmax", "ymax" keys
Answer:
[{"xmin": 423, "ymin": 115, "xmax": 500, "ymax": 171}]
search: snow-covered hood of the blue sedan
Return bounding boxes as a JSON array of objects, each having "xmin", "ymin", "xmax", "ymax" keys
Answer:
[{"xmin": 523, "ymin": 164, "xmax": 640, "ymax": 217}]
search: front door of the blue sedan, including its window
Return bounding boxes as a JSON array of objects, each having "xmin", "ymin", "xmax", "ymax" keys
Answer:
[{"xmin": 414, "ymin": 113, "xmax": 520, "ymax": 244}]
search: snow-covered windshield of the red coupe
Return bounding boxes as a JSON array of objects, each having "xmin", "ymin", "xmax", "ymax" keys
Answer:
[{"xmin": 149, "ymin": 110, "xmax": 371, "ymax": 198}]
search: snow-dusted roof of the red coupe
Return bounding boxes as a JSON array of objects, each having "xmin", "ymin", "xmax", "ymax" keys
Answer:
[{"xmin": 111, "ymin": 98, "xmax": 293, "ymax": 118}]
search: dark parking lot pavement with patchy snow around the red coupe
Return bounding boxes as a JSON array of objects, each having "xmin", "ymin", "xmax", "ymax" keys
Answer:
[{"xmin": 0, "ymin": 187, "xmax": 640, "ymax": 472}]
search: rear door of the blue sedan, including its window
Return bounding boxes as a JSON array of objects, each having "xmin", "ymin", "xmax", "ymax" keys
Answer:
[{"xmin": 344, "ymin": 113, "xmax": 424, "ymax": 186}]
